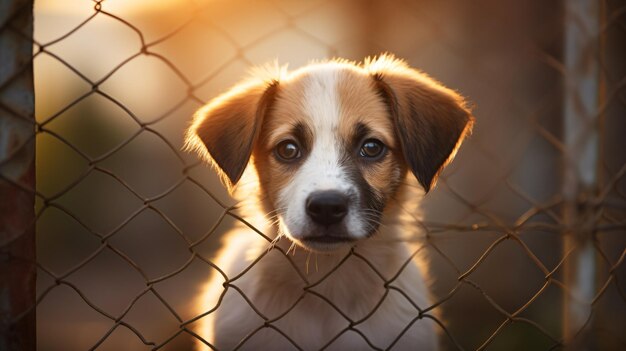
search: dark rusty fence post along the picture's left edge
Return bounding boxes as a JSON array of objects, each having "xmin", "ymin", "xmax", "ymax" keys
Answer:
[{"xmin": 0, "ymin": 0, "xmax": 36, "ymax": 351}]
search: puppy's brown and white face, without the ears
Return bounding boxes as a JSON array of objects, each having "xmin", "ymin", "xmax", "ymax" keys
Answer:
[{"xmin": 253, "ymin": 66, "xmax": 406, "ymax": 250}]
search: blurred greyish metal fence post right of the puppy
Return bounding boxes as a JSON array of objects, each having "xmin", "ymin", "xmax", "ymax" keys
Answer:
[{"xmin": 562, "ymin": 0, "xmax": 602, "ymax": 346}]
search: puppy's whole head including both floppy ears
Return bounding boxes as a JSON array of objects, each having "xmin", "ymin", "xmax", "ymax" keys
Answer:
[{"xmin": 187, "ymin": 55, "xmax": 473, "ymax": 251}]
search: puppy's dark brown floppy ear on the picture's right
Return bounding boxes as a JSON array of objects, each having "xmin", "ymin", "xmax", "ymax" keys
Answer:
[{"xmin": 370, "ymin": 56, "xmax": 474, "ymax": 192}]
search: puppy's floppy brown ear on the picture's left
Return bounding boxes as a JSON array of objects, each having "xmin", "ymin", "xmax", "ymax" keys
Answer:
[{"xmin": 185, "ymin": 81, "xmax": 278, "ymax": 192}]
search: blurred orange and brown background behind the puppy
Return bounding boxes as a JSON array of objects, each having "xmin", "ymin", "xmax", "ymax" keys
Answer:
[{"xmin": 25, "ymin": 0, "xmax": 626, "ymax": 350}]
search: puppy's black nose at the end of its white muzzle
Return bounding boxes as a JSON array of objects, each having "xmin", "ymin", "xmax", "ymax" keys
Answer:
[{"xmin": 306, "ymin": 190, "xmax": 348, "ymax": 225}]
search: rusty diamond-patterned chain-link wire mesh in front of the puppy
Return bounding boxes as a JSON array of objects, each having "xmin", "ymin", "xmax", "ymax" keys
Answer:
[{"xmin": 0, "ymin": 0, "xmax": 626, "ymax": 350}]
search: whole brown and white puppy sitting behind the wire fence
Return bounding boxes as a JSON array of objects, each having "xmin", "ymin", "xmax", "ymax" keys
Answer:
[{"xmin": 186, "ymin": 55, "xmax": 473, "ymax": 350}]
